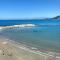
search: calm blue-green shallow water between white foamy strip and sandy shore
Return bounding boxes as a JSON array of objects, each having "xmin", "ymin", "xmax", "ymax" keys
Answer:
[{"xmin": 0, "ymin": 21, "xmax": 60, "ymax": 52}]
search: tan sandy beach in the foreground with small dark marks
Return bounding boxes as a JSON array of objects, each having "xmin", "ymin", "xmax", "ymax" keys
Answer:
[{"xmin": 0, "ymin": 38, "xmax": 60, "ymax": 60}]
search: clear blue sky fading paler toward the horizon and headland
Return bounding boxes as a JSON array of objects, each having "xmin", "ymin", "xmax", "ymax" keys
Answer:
[{"xmin": 0, "ymin": 0, "xmax": 60, "ymax": 19}]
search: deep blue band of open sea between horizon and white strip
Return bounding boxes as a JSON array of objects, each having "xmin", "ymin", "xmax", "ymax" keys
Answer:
[{"xmin": 0, "ymin": 19, "xmax": 60, "ymax": 26}]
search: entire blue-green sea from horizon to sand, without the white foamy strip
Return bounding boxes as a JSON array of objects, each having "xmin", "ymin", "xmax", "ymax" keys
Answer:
[{"xmin": 0, "ymin": 19, "xmax": 60, "ymax": 53}]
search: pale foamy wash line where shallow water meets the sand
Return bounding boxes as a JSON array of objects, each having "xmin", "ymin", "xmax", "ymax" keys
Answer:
[{"xmin": 0, "ymin": 35, "xmax": 60, "ymax": 59}]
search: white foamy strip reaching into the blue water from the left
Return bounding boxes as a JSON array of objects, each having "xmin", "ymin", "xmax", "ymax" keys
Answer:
[{"xmin": 0, "ymin": 24, "xmax": 37, "ymax": 30}]
